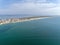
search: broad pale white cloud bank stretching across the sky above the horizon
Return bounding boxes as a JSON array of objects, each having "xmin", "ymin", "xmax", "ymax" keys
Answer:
[{"xmin": 0, "ymin": 0, "xmax": 60, "ymax": 15}]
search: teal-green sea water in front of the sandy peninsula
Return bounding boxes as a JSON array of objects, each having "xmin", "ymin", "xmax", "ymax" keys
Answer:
[{"xmin": 0, "ymin": 17, "xmax": 60, "ymax": 45}]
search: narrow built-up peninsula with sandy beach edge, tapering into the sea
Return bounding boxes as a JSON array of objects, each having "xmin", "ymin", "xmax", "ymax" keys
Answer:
[{"xmin": 0, "ymin": 16, "xmax": 51, "ymax": 25}]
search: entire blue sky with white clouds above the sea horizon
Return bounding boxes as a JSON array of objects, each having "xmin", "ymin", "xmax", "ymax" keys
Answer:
[{"xmin": 0, "ymin": 0, "xmax": 60, "ymax": 15}]
